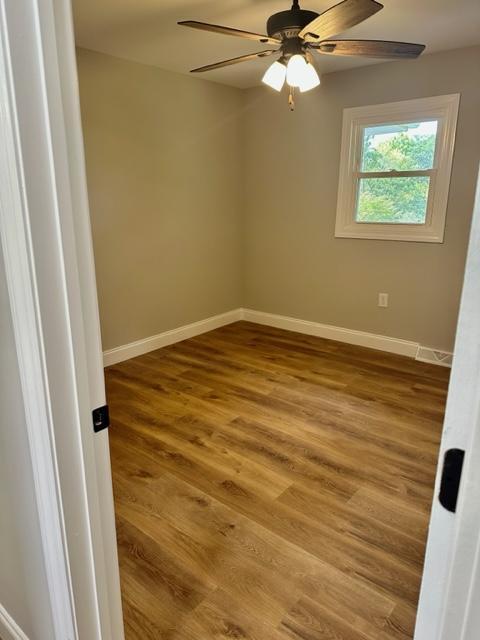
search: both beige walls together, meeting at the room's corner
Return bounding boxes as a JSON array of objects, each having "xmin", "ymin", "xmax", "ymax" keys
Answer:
[{"xmin": 78, "ymin": 47, "xmax": 480, "ymax": 350}]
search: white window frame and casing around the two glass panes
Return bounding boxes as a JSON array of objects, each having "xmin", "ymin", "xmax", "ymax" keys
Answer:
[{"xmin": 335, "ymin": 93, "xmax": 460, "ymax": 242}]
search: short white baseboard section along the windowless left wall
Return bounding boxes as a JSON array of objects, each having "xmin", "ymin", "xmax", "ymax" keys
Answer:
[{"xmin": 103, "ymin": 309, "xmax": 243, "ymax": 367}]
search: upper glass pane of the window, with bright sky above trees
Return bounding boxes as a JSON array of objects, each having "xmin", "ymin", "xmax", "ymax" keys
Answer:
[{"xmin": 360, "ymin": 120, "xmax": 438, "ymax": 172}]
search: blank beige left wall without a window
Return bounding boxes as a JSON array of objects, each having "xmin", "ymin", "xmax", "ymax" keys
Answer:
[{"xmin": 78, "ymin": 50, "xmax": 242, "ymax": 349}]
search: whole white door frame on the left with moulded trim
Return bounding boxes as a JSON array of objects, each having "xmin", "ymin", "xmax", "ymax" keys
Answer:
[{"xmin": 0, "ymin": 0, "xmax": 123, "ymax": 640}]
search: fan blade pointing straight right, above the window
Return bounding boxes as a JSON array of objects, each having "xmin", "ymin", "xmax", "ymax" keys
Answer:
[{"xmin": 311, "ymin": 40, "xmax": 425, "ymax": 59}]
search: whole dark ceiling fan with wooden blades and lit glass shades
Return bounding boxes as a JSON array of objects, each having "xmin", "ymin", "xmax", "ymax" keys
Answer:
[{"xmin": 178, "ymin": 0, "xmax": 425, "ymax": 102}]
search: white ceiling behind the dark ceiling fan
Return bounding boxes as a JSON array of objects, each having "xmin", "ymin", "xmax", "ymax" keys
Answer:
[{"xmin": 73, "ymin": 0, "xmax": 480, "ymax": 88}]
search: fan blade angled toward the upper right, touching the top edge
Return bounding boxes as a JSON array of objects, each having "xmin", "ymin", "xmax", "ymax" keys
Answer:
[{"xmin": 299, "ymin": 0, "xmax": 383, "ymax": 42}]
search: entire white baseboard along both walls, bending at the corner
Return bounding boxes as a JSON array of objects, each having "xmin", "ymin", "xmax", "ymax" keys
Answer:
[{"xmin": 103, "ymin": 309, "xmax": 452, "ymax": 367}]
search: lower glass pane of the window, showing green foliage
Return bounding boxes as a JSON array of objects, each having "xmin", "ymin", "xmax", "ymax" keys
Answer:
[{"xmin": 356, "ymin": 176, "xmax": 430, "ymax": 224}]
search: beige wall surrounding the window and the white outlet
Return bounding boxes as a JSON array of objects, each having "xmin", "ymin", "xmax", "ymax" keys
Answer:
[{"xmin": 244, "ymin": 47, "xmax": 480, "ymax": 350}]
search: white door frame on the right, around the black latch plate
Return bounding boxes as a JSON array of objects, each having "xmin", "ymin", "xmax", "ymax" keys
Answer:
[{"xmin": 415, "ymin": 166, "xmax": 480, "ymax": 640}]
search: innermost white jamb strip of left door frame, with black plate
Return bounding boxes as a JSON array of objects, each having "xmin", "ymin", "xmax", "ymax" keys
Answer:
[{"xmin": 46, "ymin": 0, "xmax": 124, "ymax": 640}]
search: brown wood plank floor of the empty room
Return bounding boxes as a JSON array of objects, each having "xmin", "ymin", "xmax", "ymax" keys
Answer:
[{"xmin": 107, "ymin": 322, "xmax": 449, "ymax": 640}]
